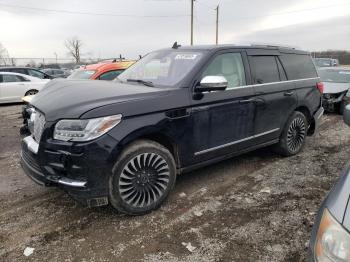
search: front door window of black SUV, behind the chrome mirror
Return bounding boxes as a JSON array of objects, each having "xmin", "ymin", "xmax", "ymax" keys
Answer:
[{"xmin": 202, "ymin": 53, "xmax": 246, "ymax": 89}]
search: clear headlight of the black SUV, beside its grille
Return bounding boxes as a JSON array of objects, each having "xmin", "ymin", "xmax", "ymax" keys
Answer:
[{"xmin": 53, "ymin": 115, "xmax": 122, "ymax": 141}]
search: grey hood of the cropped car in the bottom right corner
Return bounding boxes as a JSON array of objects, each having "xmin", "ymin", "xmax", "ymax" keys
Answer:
[{"xmin": 325, "ymin": 163, "xmax": 350, "ymax": 230}]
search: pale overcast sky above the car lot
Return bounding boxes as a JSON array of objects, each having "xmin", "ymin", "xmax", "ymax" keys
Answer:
[{"xmin": 0, "ymin": 0, "xmax": 350, "ymax": 59}]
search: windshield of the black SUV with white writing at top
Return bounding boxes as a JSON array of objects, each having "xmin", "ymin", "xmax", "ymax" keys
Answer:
[{"xmin": 118, "ymin": 50, "xmax": 203, "ymax": 86}]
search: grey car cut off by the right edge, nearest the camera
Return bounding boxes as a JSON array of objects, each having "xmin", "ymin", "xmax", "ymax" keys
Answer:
[{"xmin": 309, "ymin": 105, "xmax": 350, "ymax": 262}]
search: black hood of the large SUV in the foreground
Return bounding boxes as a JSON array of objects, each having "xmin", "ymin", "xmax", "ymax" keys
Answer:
[{"xmin": 31, "ymin": 80, "xmax": 178, "ymax": 121}]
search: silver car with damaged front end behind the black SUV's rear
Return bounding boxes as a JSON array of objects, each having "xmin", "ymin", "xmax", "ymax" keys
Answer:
[{"xmin": 318, "ymin": 67, "xmax": 350, "ymax": 114}]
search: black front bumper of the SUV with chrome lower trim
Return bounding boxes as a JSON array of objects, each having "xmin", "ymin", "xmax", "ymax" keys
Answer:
[{"xmin": 21, "ymin": 135, "xmax": 118, "ymax": 206}]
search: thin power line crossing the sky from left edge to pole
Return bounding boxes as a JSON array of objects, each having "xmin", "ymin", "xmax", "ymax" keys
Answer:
[{"xmin": 0, "ymin": 3, "xmax": 190, "ymax": 18}]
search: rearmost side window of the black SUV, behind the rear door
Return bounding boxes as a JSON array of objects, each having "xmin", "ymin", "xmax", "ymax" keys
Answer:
[{"xmin": 280, "ymin": 54, "xmax": 317, "ymax": 80}]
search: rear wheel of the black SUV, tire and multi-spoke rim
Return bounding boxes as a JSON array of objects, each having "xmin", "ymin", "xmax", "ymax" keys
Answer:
[{"xmin": 276, "ymin": 111, "xmax": 308, "ymax": 156}]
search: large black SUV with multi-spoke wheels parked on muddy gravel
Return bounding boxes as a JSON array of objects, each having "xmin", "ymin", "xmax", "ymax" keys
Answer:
[{"xmin": 21, "ymin": 45, "xmax": 323, "ymax": 214}]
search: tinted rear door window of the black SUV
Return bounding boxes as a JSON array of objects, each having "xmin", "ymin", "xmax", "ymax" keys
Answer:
[{"xmin": 249, "ymin": 56, "xmax": 280, "ymax": 84}]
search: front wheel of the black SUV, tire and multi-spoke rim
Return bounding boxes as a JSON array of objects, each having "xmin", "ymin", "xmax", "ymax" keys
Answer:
[{"xmin": 109, "ymin": 140, "xmax": 176, "ymax": 215}]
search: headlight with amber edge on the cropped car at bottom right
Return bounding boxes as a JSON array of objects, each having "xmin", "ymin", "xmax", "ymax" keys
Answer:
[{"xmin": 315, "ymin": 209, "xmax": 350, "ymax": 262}]
